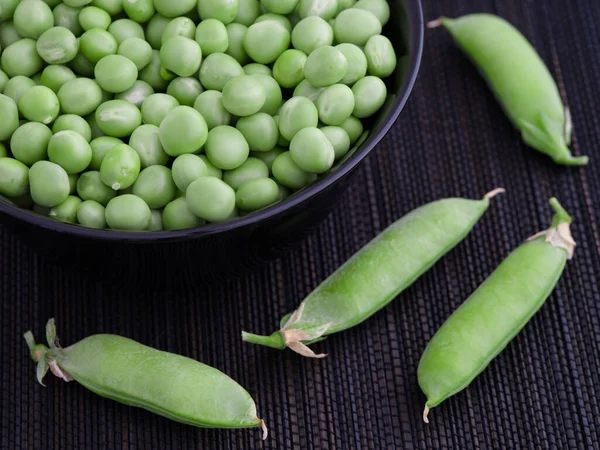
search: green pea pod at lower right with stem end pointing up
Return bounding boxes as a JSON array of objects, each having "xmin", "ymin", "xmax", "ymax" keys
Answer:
[{"xmin": 417, "ymin": 198, "xmax": 575, "ymax": 422}]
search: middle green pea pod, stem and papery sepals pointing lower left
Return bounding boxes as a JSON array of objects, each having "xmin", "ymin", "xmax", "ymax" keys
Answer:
[{"xmin": 242, "ymin": 189, "xmax": 504, "ymax": 358}]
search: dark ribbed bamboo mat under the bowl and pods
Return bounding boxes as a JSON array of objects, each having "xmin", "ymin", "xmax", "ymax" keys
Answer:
[{"xmin": 0, "ymin": 0, "xmax": 600, "ymax": 450}]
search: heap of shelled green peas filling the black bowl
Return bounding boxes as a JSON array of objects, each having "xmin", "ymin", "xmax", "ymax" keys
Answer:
[{"xmin": 0, "ymin": 0, "xmax": 397, "ymax": 231}]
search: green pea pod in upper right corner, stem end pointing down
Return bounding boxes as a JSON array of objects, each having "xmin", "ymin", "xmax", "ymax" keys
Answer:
[{"xmin": 428, "ymin": 14, "xmax": 588, "ymax": 166}]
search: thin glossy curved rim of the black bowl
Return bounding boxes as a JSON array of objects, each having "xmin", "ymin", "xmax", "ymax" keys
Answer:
[{"xmin": 0, "ymin": 0, "xmax": 425, "ymax": 243}]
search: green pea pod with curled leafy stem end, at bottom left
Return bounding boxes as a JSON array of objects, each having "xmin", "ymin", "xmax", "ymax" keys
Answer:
[{"xmin": 24, "ymin": 319, "xmax": 267, "ymax": 439}]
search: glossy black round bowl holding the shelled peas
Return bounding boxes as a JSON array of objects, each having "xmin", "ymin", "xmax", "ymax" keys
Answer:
[{"xmin": 0, "ymin": 0, "xmax": 424, "ymax": 280}]
